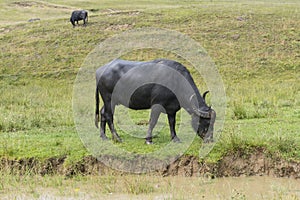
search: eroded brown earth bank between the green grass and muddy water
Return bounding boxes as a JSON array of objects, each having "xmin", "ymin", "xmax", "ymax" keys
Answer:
[{"xmin": 0, "ymin": 149, "xmax": 300, "ymax": 179}]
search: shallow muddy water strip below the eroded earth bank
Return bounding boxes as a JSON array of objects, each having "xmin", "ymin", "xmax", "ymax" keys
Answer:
[{"xmin": 0, "ymin": 175, "xmax": 300, "ymax": 200}]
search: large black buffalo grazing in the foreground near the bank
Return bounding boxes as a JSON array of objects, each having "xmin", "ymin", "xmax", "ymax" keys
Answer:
[{"xmin": 95, "ymin": 59, "xmax": 216, "ymax": 144}]
